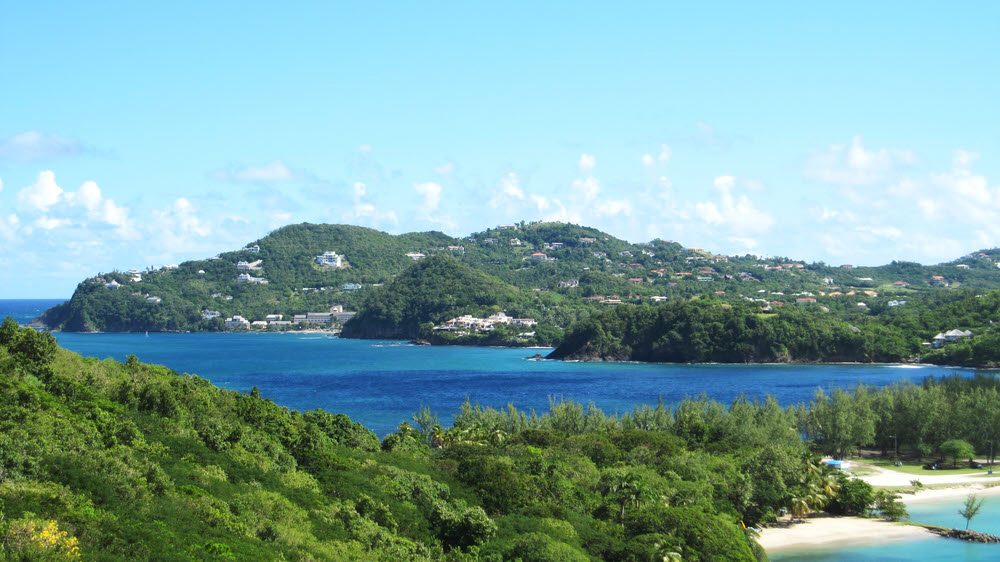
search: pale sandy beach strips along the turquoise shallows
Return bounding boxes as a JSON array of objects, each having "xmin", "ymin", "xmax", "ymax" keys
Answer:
[{"xmin": 759, "ymin": 463, "xmax": 1000, "ymax": 553}]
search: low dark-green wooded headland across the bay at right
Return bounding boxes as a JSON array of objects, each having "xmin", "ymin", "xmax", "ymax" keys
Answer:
[{"xmin": 549, "ymin": 291, "xmax": 1000, "ymax": 367}]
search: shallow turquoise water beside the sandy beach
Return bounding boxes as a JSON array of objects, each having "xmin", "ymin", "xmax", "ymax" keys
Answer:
[{"xmin": 771, "ymin": 496, "xmax": 1000, "ymax": 562}]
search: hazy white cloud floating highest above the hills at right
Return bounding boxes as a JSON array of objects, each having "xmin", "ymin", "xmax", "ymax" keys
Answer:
[{"xmin": 803, "ymin": 135, "xmax": 918, "ymax": 186}]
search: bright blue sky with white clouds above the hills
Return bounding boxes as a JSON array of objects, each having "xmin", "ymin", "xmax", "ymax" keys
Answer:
[{"xmin": 0, "ymin": 1, "xmax": 1000, "ymax": 298}]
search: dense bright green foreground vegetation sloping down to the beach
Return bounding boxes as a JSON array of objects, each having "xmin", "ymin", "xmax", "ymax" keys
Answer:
[{"xmin": 0, "ymin": 319, "xmax": 924, "ymax": 561}]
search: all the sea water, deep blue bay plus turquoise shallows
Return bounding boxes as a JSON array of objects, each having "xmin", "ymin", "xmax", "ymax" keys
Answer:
[{"xmin": 0, "ymin": 300, "xmax": 1000, "ymax": 560}]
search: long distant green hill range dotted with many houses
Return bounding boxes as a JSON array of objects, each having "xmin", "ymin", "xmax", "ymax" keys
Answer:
[{"xmin": 38, "ymin": 222, "xmax": 1000, "ymax": 344}]
